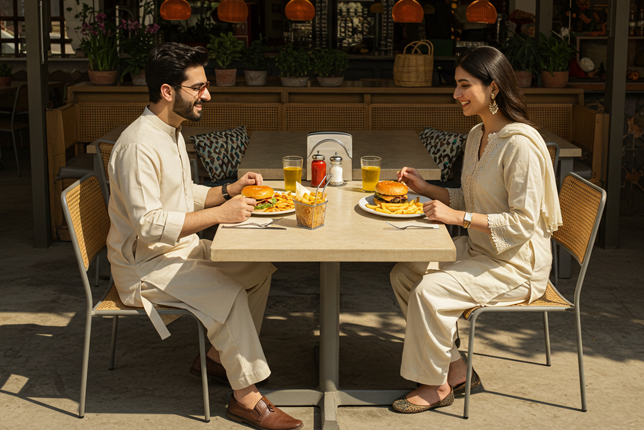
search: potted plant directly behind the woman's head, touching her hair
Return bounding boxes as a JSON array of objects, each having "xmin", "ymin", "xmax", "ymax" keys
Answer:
[{"xmin": 503, "ymin": 34, "xmax": 541, "ymax": 88}]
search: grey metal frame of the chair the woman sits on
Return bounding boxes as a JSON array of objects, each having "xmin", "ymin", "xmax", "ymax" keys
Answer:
[{"xmin": 463, "ymin": 173, "xmax": 606, "ymax": 419}]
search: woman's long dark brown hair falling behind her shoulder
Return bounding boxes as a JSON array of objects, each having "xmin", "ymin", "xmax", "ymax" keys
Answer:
[{"xmin": 456, "ymin": 46, "xmax": 534, "ymax": 126}]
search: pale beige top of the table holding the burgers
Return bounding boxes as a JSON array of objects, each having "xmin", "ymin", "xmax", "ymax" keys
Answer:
[{"xmin": 211, "ymin": 181, "xmax": 456, "ymax": 262}]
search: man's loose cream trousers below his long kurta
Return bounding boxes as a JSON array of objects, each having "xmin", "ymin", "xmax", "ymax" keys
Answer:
[{"xmin": 141, "ymin": 263, "xmax": 271, "ymax": 390}]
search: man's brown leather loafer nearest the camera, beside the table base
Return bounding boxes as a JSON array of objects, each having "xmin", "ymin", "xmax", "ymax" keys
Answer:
[{"xmin": 226, "ymin": 395, "xmax": 302, "ymax": 430}]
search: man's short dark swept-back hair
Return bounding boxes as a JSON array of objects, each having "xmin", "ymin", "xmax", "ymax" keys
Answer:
[{"xmin": 145, "ymin": 42, "xmax": 208, "ymax": 103}]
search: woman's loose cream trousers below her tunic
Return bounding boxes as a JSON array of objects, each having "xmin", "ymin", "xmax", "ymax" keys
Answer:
[{"xmin": 390, "ymin": 263, "xmax": 530, "ymax": 385}]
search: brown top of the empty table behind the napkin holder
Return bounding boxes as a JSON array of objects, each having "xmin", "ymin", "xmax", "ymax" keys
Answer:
[{"xmin": 238, "ymin": 130, "xmax": 441, "ymax": 181}]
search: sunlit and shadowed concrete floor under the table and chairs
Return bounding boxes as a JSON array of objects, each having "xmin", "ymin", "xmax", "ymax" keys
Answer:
[{"xmin": 0, "ymin": 146, "xmax": 644, "ymax": 430}]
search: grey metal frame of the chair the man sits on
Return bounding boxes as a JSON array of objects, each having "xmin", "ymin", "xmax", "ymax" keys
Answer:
[{"xmin": 61, "ymin": 174, "xmax": 210, "ymax": 422}]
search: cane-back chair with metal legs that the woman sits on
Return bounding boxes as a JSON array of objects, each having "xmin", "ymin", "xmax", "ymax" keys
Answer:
[{"xmin": 463, "ymin": 173, "xmax": 606, "ymax": 418}]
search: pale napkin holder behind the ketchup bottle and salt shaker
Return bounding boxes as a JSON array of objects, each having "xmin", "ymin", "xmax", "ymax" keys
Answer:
[{"xmin": 306, "ymin": 131, "xmax": 353, "ymax": 182}]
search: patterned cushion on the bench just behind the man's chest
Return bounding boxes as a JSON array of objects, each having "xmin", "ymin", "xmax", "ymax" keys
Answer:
[{"xmin": 190, "ymin": 125, "xmax": 248, "ymax": 182}]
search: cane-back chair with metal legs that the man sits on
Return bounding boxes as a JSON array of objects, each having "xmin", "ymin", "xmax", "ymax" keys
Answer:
[{"xmin": 61, "ymin": 175, "xmax": 210, "ymax": 422}]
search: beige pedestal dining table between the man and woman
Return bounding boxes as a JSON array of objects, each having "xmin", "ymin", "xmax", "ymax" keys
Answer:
[{"xmin": 211, "ymin": 181, "xmax": 456, "ymax": 430}]
